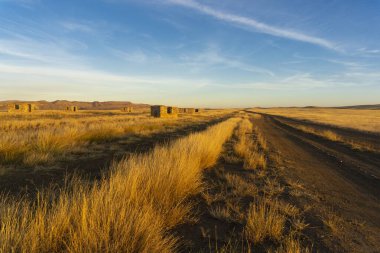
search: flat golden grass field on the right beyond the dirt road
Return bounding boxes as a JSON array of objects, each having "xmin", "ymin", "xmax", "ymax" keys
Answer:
[{"xmin": 252, "ymin": 108, "xmax": 380, "ymax": 133}]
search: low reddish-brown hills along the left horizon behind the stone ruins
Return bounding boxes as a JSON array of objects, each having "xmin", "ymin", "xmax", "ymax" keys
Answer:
[{"xmin": 0, "ymin": 100, "xmax": 150, "ymax": 111}]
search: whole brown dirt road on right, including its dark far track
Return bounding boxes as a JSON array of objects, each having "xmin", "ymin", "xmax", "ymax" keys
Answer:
[{"xmin": 256, "ymin": 115, "xmax": 380, "ymax": 252}]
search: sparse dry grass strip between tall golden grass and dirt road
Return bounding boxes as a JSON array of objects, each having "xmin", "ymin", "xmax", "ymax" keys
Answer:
[{"xmin": 189, "ymin": 115, "xmax": 311, "ymax": 253}]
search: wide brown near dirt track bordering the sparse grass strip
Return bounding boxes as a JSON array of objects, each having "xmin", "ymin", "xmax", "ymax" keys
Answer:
[{"xmin": 256, "ymin": 115, "xmax": 380, "ymax": 252}]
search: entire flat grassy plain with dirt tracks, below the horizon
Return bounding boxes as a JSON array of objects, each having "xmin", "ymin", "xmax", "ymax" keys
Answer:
[{"xmin": 0, "ymin": 103, "xmax": 380, "ymax": 253}]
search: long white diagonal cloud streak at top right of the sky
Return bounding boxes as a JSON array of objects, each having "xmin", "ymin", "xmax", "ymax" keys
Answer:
[{"xmin": 165, "ymin": 0, "xmax": 341, "ymax": 51}]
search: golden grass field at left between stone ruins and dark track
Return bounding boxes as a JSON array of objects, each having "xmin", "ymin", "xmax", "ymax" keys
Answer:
[{"xmin": 0, "ymin": 111, "xmax": 230, "ymax": 166}]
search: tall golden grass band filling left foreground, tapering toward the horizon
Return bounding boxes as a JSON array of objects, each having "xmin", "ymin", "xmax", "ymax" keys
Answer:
[{"xmin": 0, "ymin": 119, "xmax": 237, "ymax": 253}]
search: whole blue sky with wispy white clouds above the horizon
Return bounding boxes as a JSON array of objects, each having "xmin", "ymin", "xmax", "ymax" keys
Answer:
[{"xmin": 0, "ymin": 0, "xmax": 380, "ymax": 107}]
